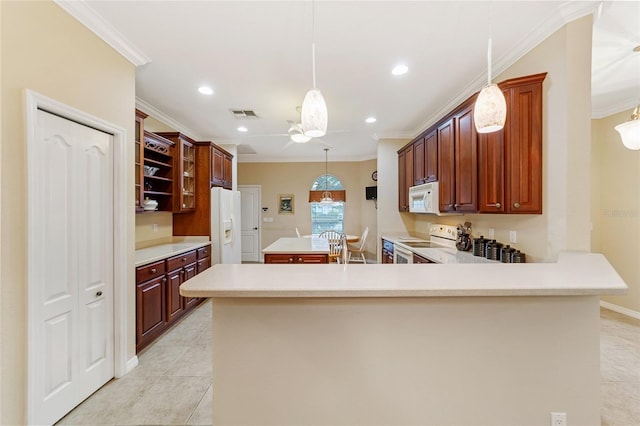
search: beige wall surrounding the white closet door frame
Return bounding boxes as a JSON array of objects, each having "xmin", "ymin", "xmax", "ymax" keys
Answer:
[{"xmin": 0, "ymin": 1, "xmax": 135, "ymax": 424}]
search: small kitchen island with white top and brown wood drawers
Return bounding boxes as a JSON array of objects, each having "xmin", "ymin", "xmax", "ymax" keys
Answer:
[{"xmin": 262, "ymin": 237, "xmax": 329, "ymax": 263}]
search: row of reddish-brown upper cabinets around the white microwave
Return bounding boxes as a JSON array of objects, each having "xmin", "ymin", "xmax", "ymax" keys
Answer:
[{"xmin": 398, "ymin": 73, "xmax": 547, "ymax": 214}]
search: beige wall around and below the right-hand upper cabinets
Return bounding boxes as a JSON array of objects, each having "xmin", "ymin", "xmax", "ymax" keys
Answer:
[{"xmin": 402, "ymin": 16, "xmax": 591, "ymax": 261}]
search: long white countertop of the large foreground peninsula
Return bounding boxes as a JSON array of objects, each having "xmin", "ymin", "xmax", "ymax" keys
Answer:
[{"xmin": 180, "ymin": 252, "xmax": 627, "ymax": 298}]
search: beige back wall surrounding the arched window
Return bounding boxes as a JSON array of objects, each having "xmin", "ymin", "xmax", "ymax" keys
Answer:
[{"xmin": 237, "ymin": 160, "xmax": 380, "ymax": 256}]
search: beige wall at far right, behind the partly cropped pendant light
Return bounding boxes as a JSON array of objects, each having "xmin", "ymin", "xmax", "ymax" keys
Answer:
[{"xmin": 591, "ymin": 110, "xmax": 640, "ymax": 313}]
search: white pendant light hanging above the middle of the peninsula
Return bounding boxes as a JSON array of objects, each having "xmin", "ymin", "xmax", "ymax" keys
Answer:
[{"xmin": 300, "ymin": 2, "xmax": 329, "ymax": 138}]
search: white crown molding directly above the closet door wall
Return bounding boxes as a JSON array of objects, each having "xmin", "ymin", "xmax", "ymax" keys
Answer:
[{"xmin": 53, "ymin": 0, "xmax": 151, "ymax": 67}]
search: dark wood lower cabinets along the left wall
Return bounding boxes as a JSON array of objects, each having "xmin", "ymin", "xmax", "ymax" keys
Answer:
[{"xmin": 136, "ymin": 246, "xmax": 211, "ymax": 352}]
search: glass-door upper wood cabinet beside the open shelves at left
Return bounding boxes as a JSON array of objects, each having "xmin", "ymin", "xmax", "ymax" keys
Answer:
[{"xmin": 158, "ymin": 132, "xmax": 196, "ymax": 213}]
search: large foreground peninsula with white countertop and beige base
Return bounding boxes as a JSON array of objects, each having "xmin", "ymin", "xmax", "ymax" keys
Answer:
[{"xmin": 181, "ymin": 252, "xmax": 627, "ymax": 425}]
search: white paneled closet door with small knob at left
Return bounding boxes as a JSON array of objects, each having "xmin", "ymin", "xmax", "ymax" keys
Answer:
[{"xmin": 29, "ymin": 111, "xmax": 113, "ymax": 424}]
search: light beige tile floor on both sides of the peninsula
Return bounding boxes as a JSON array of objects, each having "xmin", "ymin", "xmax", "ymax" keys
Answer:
[{"xmin": 58, "ymin": 302, "xmax": 640, "ymax": 426}]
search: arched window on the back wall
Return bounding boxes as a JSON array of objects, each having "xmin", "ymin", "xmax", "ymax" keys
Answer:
[{"xmin": 311, "ymin": 175, "xmax": 344, "ymax": 235}]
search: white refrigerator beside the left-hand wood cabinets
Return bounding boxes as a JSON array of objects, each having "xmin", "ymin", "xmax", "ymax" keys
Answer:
[{"xmin": 211, "ymin": 187, "xmax": 241, "ymax": 265}]
